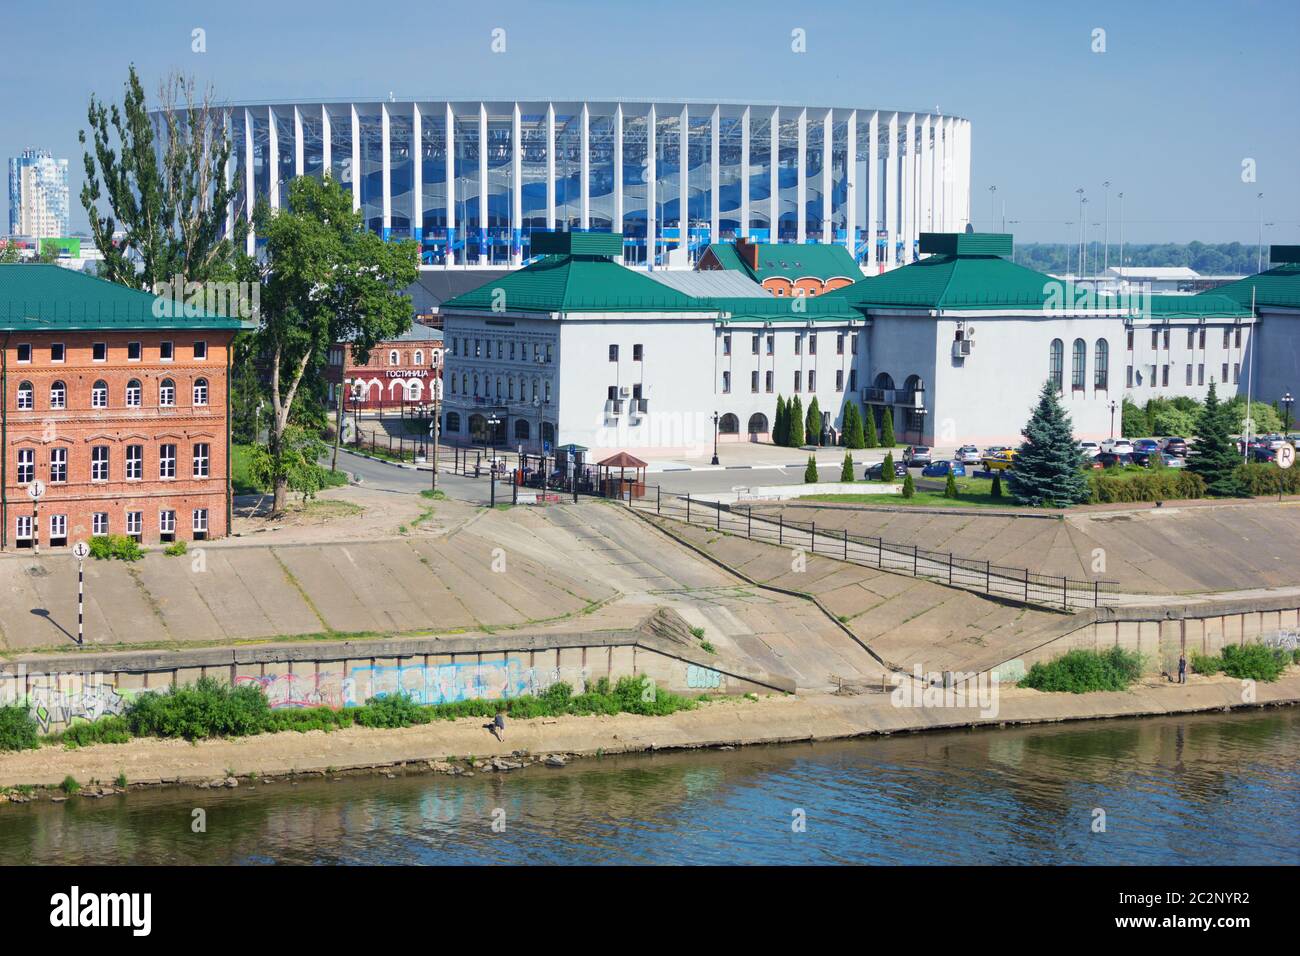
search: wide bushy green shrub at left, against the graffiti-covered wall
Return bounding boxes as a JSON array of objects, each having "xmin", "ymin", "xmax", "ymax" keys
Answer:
[{"xmin": 126, "ymin": 678, "xmax": 274, "ymax": 740}]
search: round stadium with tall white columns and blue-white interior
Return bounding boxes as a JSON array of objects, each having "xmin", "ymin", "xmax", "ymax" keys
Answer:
[{"xmin": 162, "ymin": 96, "xmax": 971, "ymax": 273}]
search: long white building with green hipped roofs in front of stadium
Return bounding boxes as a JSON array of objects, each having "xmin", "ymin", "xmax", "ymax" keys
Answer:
[{"xmin": 441, "ymin": 233, "xmax": 1256, "ymax": 458}]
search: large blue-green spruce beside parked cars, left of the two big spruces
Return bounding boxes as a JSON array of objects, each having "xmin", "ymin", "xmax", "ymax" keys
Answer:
[{"xmin": 1006, "ymin": 381, "xmax": 1088, "ymax": 507}]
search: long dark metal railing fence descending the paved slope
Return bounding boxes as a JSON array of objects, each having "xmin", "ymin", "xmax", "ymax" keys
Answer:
[{"xmin": 625, "ymin": 485, "xmax": 1118, "ymax": 610}]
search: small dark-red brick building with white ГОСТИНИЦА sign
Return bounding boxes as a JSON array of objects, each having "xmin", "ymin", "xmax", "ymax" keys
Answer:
[{"xmin": 328, "ymin": 323, "xmax": 442, "ymax": 411}]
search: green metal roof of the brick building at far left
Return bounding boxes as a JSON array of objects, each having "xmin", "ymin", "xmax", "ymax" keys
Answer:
[{"xmin": 0, "ymin": 264, "xmax": 250, "ymax": 332}]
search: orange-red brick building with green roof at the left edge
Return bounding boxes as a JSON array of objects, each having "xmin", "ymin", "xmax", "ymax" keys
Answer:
[{"xmin": 0, "ymin": 265, "xmax": 242, "ymax": 550}]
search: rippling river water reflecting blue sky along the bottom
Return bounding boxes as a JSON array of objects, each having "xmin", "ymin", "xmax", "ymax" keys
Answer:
[{"xmin": 0, "ymin": 708, "xmax": 1300, "ymax": 864}]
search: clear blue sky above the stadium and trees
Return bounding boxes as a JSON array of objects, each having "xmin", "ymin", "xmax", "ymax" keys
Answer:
[{"xmin": 0, "ymin": 0, "xmax": 1300, "ymax": 243}]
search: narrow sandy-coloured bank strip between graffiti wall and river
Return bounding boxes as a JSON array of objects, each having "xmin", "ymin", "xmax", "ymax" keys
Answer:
[{"xmin": 0, "ymin": 667, "xmax": 1300, "ymax": 787}]
